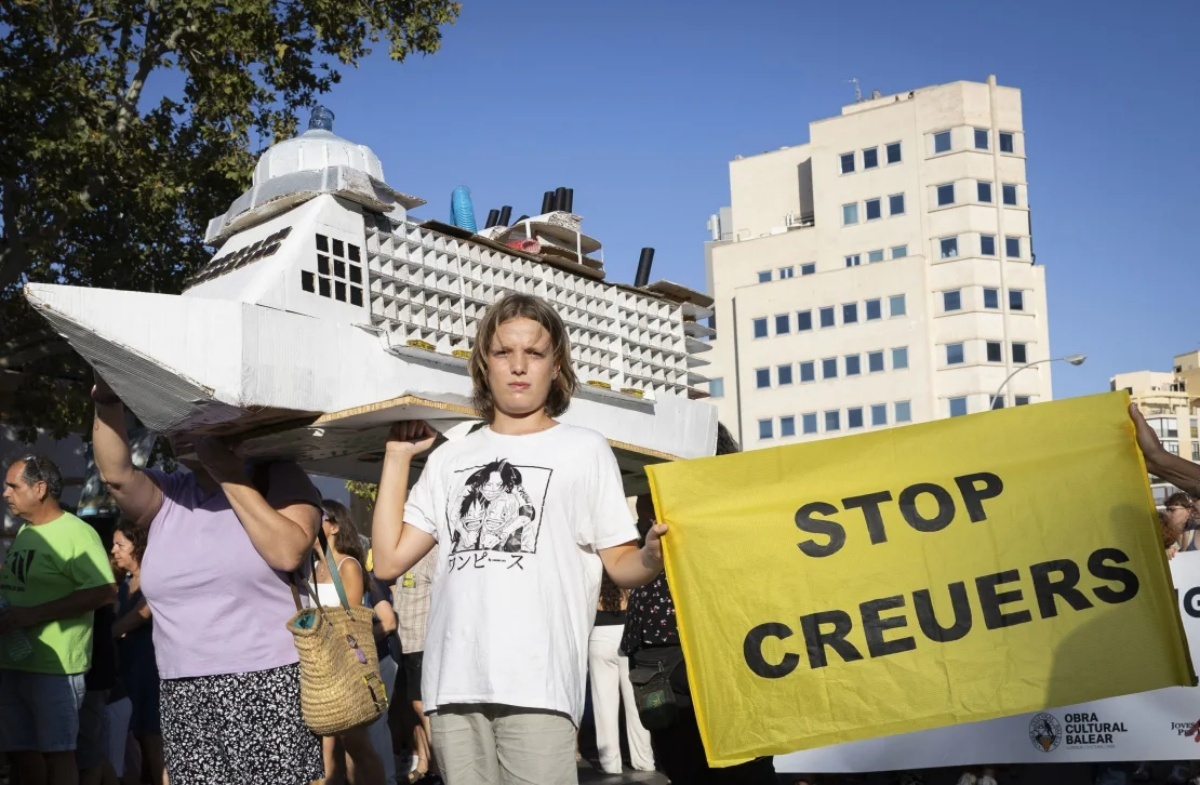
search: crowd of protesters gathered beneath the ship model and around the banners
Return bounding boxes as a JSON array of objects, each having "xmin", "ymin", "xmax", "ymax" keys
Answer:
[{"xmin": 0, "ymin": 294, "xmax": 1200, "ymax": 785}]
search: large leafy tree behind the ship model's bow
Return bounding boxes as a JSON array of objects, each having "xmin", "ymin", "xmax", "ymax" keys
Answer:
[{"xmin": 0, "ymin": 0, "xmax": 460, "ymax": 435}]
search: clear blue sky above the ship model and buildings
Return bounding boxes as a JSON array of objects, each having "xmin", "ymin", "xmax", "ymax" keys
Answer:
[{"xmin": 324, "ymin": 0, "xmax": 1200, "ymax": 397}]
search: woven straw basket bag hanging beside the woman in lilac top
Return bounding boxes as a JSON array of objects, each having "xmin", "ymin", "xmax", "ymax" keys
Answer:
[{"xmin": 288, "ymin": 546, "xmax": 388, "ymax": 736}]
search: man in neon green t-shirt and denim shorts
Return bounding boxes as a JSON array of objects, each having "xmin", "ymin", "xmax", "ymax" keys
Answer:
[{"xmin": 0, "ymin": 455, "xmax": 116, "ymax": 785}]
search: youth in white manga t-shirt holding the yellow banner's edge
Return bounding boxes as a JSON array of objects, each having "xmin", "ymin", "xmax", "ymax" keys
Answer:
[{"xmin": 372, "ymin": 294, "xmax": 666, "ymax": 785}]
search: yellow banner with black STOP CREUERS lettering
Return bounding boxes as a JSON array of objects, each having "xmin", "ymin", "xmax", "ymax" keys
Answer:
[{"xmin": 648, "ymin": 393, "xmax": 1195, "ymax": 765}]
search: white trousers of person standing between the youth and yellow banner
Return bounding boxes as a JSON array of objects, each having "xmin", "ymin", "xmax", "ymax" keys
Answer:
[{"xmin": 588, "ymin": 624, "xmax": 654, "ymax": 774}]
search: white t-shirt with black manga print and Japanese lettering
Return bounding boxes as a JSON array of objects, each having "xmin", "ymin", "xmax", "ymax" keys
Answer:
[{"xmin": 404, "ymin": 424, "xmax": 637, "ymax": 725}]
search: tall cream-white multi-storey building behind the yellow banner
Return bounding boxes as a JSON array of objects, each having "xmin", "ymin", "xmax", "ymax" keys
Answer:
[{"xmin": 706, "ymin": 77, "xmax": 1051, "ymax": 448}]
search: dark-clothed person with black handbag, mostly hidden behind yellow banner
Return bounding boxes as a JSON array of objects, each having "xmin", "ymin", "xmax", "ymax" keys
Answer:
[{"xmin": 620, "ymin": 424, "xmax": 775, "ymax": 785}]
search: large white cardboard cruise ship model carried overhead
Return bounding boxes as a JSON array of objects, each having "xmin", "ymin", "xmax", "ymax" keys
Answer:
[{"xmin": 25, "ymin": 108, "xmax": 716, "ymax": 492}]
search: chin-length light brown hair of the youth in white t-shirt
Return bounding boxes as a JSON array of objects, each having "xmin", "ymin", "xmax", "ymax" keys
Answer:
[{"xmin": 467, "ymin": 294, "xmax": 580, "ymax": 423}]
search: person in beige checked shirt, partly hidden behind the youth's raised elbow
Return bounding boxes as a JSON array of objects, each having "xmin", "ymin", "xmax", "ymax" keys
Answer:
[{"xmin": 395, "ymin": 545, "xmax": 438, "ymax": 783}]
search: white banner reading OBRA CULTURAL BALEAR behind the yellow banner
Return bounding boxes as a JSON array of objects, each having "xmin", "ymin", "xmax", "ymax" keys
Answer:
[{"xmin": 775, "ymin": 552, "xmax": 1200, "ymax": 773}]
